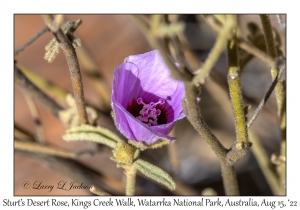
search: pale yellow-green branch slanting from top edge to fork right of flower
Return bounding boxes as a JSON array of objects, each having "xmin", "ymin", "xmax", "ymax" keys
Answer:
[{"xmin": 193, "ymin": 15, "xmax": 236, "ymax": 84}]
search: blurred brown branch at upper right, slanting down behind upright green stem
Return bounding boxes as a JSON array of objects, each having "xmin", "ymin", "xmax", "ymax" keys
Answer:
[{"xmin": 205, "ymin": 15, "xmax": 276, "ymax": 66}]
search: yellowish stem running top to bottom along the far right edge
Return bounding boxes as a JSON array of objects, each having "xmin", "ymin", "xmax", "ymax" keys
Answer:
[{"xmin": 260, "ymin": 15, "xmax": 286, "ymax": 195}]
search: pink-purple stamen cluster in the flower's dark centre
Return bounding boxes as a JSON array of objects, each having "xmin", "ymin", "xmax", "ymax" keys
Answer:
[{"xmin": 136, "ymin": 98, "xmax": 165, "ymax": 126}]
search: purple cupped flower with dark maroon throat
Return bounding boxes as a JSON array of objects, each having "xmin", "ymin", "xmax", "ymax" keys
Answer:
[{"xmin": 112, "ymin": 50, "xmax": 185, "ymax": 145}]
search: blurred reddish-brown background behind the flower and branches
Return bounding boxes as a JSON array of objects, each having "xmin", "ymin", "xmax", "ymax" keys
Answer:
[{"xmin": 14, "ymin": 15, "xmax": 285, "ymax": 196}]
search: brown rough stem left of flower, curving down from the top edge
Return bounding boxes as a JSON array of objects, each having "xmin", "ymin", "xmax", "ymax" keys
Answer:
[{"xmin": 43, "ymin": 15, "xmax": 88, "ymax": 124}]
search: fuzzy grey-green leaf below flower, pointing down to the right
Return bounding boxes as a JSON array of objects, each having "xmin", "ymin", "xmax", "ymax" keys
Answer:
[{"xmin": 133, "ymin": 159, "xmax": 176, "ymax": 190}]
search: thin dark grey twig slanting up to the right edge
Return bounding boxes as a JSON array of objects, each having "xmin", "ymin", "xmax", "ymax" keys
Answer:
[{"xmin": 247, "ymin": 63, "xmax": 285, "ymax": 129}]
